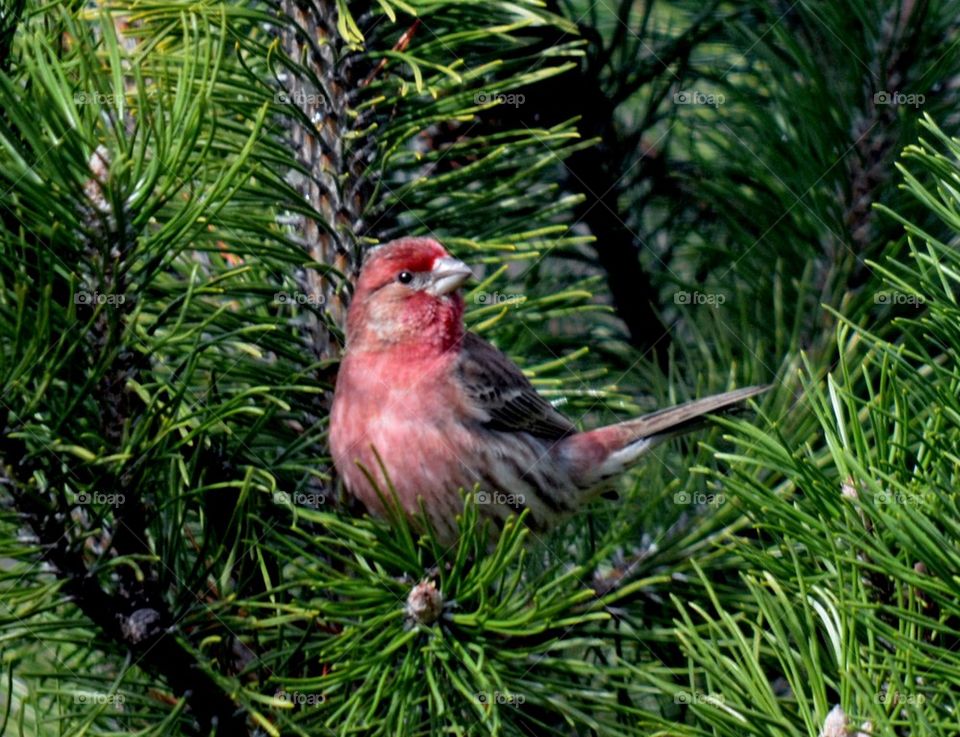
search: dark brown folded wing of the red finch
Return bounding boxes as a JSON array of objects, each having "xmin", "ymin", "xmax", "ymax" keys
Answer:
[{"xmin": 457, "ymin": 333, "xmax": 576, "ymax": 440}]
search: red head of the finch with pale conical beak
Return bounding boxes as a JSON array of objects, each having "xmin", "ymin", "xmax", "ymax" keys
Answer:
[{"xmin": 347, "ymin": 238, "xmax": 472, "ymax": 351}]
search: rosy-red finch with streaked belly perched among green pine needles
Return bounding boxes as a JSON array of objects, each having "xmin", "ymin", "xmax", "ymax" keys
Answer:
[{"xmin": 330, "ymin": 238, "xmax": 766, "ymax": 542}]
